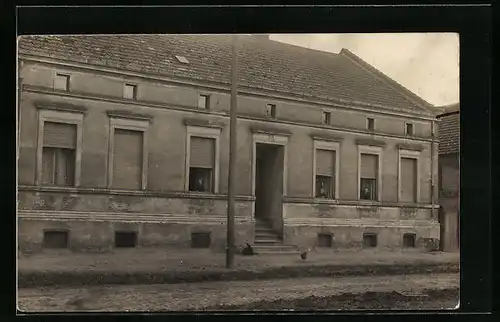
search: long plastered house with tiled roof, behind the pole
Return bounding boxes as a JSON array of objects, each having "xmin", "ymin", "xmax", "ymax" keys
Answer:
[{"xmin": 18, "ymin": 35, "xmax": 440, "ymax": 252}]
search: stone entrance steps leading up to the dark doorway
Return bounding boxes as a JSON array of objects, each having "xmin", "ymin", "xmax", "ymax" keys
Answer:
[{"xmin": 252, "ymin": 218, "xmax": 298, "ymax": 254}]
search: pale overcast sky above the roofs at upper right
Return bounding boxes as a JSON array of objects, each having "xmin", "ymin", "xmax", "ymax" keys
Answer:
[{"xmin": 271, "ymin": 33, "xmax": 459, "ymax": 106}]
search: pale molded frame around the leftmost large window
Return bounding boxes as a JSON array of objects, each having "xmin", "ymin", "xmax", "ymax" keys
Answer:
[{"xmin": 35, "ymin": 110, "xmax": 84, "ymax": 188}]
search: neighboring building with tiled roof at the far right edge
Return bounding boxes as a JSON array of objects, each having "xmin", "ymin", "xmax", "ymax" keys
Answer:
[{"xmin": 438, "ymin": 104, "xmax": 460, "ymax": 252}]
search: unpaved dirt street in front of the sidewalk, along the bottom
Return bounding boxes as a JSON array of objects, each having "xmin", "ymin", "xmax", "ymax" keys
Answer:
[{"xmin": 18, "ymin": 274, "xmax": 460, "ymax": 312}]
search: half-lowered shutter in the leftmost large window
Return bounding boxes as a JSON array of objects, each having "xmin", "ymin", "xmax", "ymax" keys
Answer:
[{"xmin": 43, "ymin": 122, "xmax": 76, "ymax": 149}]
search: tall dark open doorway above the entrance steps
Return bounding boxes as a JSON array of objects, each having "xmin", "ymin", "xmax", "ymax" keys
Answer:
[{"xmin": 255, "ymin": 143, "xmax": 284, "ymax": 236}]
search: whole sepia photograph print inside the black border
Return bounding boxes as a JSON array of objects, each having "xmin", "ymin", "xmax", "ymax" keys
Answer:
[{"xmin": 17, "ymin": 33, "xmax": 460, "ymax": 312}]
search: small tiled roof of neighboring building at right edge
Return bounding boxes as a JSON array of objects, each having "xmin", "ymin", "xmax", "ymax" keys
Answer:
[{"xmin": 438, "ymin": 103, "xmax": 460, "ymax": 154}]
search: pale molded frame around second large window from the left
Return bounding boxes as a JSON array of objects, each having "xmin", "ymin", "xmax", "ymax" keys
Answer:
[{"xmin": 106, "ymin": 115, "xmax": 150, "ymax": 190}]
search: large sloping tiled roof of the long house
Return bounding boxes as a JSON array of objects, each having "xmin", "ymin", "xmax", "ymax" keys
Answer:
[{"xmin": 19, "ymin": 35, "xmax": 429, "ymax": 114}]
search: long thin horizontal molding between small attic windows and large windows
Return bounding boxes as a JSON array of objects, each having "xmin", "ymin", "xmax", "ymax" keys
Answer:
[{"xmin": 23, "ymin": 85, "xmax": 432, "ymax": 142}]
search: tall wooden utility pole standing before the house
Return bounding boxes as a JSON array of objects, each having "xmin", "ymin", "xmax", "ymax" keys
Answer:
[{"xmin": 226, "ymin": 35, "xmax": 238, "ymax": 268}]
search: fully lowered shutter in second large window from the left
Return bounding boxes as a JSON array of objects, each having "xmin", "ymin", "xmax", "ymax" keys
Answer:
[{"xmin": 113, "ymin": 129, "xmax": 143, "ymax": 190}]
